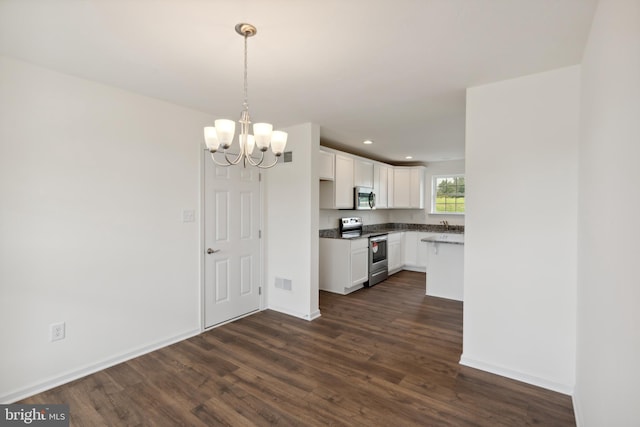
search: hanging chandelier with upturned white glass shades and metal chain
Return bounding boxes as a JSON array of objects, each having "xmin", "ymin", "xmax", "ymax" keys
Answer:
[{"xmin": 204, "ymin": 23, "xmax": 287, "ymax": 169}]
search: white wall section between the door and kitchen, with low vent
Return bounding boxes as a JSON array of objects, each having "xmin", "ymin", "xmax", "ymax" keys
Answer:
[{"xmin": 265, "ymin": 123, "xmax": 320, "ymax": 320}]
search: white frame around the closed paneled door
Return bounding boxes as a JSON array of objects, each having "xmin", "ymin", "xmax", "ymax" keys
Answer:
[{"xmin": 199, "ymin": 149, "xmax": 267, "ymax": 332}]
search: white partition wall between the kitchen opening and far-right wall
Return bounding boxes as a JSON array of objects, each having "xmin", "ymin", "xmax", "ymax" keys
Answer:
[{"xmin": 461, "ymin": 66, "xmax": 580, "ymax": 393}]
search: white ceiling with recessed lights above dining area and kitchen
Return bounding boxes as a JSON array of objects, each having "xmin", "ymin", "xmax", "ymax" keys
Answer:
[{"xmin": 0, "ymin": 0, "xmax": 596, "ymax": 164}]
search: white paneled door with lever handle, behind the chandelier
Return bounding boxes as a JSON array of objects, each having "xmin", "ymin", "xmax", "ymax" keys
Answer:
[{"xmin": 204, "ymin": 156, "xmax": 261, "ymax": 328}]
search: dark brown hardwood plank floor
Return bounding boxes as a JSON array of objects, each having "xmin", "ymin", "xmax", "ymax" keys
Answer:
[{"xmin": 20, "ymin": 271, "xmax": 575, "ymax": 426}]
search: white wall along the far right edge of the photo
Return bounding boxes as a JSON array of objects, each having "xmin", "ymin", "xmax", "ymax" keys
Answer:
[{"xmin": 574, "ymin": 0, "xmax": 640, "ymax": 426}]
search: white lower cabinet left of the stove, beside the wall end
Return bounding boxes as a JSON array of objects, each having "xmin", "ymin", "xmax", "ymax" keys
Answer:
[{"xmin": 319, "ymin": 238, "xmax": 369, "ymax": 295}]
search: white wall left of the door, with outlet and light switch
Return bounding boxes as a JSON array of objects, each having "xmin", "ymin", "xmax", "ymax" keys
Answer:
[{"xmin": 0, "ymin": 57, "xmax": 207, "ymax": 402}]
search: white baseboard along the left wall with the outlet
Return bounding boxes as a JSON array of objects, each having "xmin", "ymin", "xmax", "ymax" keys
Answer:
[{"xmin": 0, "ymin": 329, "xmax": 201, "ymax": 404}]
